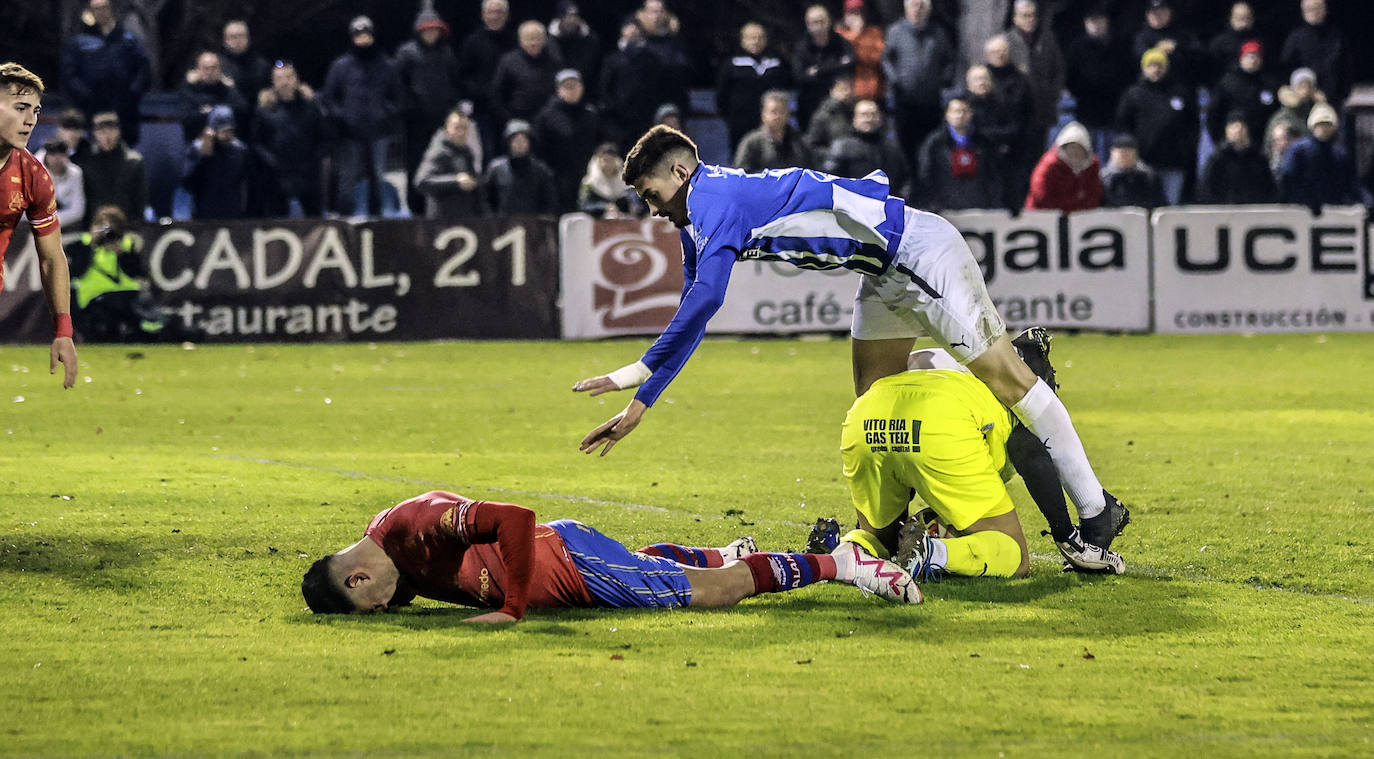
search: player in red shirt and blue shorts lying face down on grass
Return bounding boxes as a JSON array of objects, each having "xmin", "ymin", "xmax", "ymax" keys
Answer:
[{"xmin": 301, "ymin": 491, "xmax": 922, "ymax": 622}]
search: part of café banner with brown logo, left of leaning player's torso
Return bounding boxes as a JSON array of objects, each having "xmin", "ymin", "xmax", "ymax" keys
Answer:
[{"xmin": 559, "ymin": 213, "xmax": 859, "ymax": 338}]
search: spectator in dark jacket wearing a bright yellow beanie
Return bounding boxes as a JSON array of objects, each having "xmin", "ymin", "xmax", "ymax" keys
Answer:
[{"xmin": 1116, "ymin": 48, "xmax": 1198, "ymax": 205}]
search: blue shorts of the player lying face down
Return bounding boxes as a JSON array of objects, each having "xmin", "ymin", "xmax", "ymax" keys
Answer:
[{"xmin": 548, "ymin": 520, "xmax": 691, "ymax": 609}]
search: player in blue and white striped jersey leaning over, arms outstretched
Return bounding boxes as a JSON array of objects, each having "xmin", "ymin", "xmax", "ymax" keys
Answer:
[{"xmin": 573, "ymin": 127, "xmax": 1121, "ymax": 547}]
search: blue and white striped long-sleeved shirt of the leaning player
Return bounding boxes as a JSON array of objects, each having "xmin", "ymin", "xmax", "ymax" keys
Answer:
[{"xmin": 635, "ymin": 164, "xmax": 905, "ymax": 406}]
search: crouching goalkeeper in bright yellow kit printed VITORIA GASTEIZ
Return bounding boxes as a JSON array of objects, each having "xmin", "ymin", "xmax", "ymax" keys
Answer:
[{"xmin": 808, "ymin": 327, "xmax": 1129, "ymax": 582}]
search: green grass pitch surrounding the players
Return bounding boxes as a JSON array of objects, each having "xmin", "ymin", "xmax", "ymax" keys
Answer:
[{"xmin": 0, "ymin": 336, "xmax": 1374, "ymax": 758}]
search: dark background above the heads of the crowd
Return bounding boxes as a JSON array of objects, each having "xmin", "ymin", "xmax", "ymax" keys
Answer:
[{"xmin": 10, "ymin": 0, "xmax": 1374, "ymax": 96}]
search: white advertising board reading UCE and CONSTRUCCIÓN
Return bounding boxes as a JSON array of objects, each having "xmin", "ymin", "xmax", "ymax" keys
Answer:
[{"xmin": 1153, "ymin": 206, "xmax": 1374, "ymax": 334}]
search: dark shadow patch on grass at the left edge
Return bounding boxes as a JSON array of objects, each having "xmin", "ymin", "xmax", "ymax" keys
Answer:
[{"xmin": 0, "ymin": 535, "xmax": 148, "ymax": 587}]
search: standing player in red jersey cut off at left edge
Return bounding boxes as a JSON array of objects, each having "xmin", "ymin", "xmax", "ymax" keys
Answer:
[{"xmin": 0, "ymin": 63, "xmax": 77, "ymax": 388}]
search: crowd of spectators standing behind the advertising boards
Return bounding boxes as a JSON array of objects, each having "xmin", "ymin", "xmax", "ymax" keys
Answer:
[{"xmin": 43, "ymin": 0, "xmax": 1370, "ymax": 223}]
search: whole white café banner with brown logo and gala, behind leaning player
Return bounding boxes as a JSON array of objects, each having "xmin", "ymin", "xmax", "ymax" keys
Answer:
[{"xmin": 559, "ymin": 209, "xmax": 1150, "ymax": 338}]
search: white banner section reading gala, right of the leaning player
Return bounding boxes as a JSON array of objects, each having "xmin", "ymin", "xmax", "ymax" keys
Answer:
[{"xmin": 945, "ymin": 208, "xmax": 1150, "ymax": 331}]
